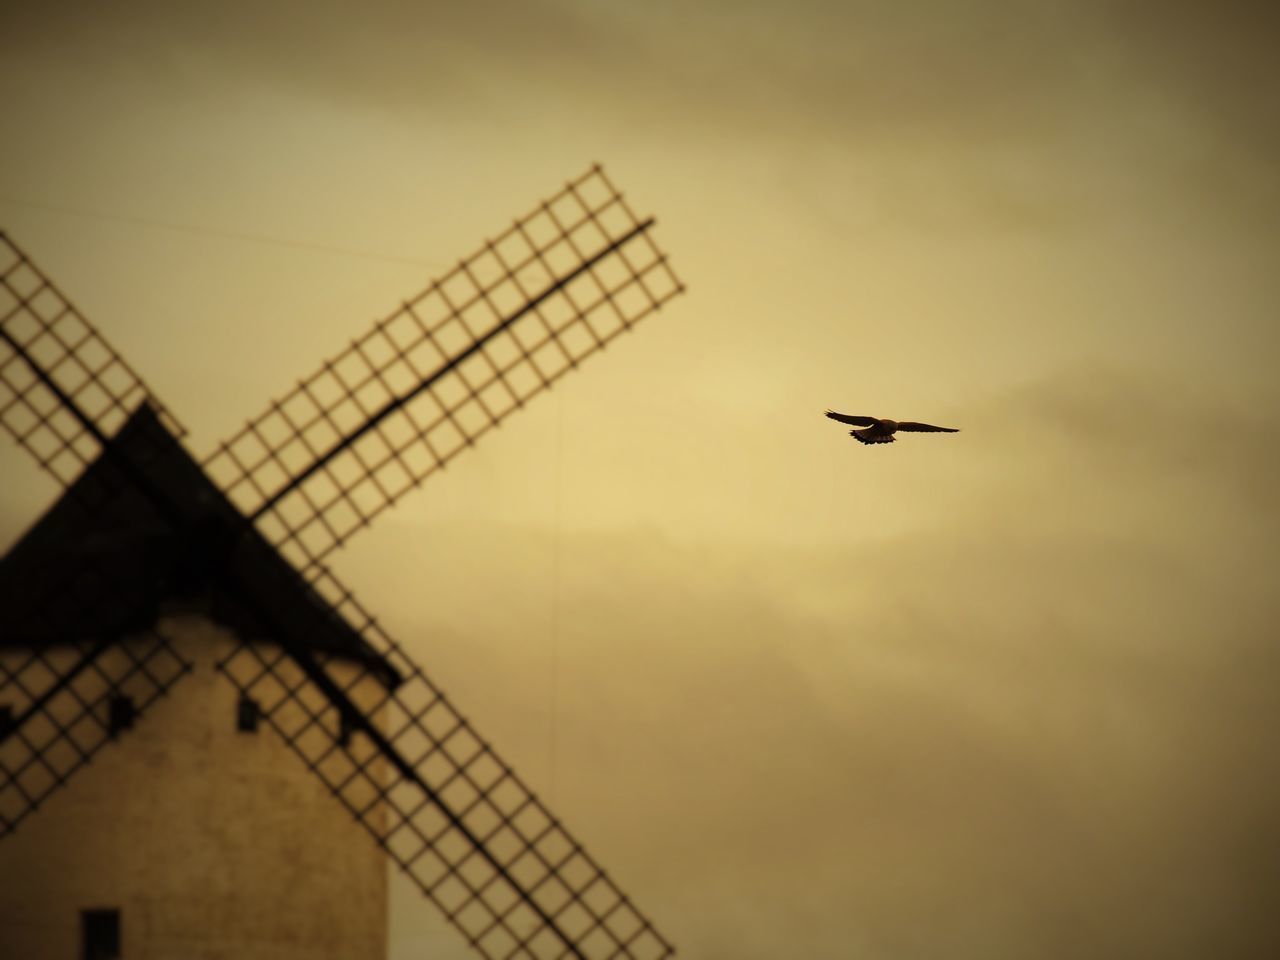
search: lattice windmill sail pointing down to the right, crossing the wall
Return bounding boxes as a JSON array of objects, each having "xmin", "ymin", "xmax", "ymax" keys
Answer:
[{"xmin": 219, "ymin": 567, "xmax": 675, "ymax": 960}]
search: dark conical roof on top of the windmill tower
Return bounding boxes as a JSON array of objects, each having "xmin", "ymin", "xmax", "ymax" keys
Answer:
[{"xmin": 0, "ymin": 404, "xmax": 394, "ymax": 677}]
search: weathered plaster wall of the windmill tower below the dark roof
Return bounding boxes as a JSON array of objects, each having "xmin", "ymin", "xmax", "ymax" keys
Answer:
[{"xmin": 0, "ymin": 616, "xmax": 387, "ymax": 960}]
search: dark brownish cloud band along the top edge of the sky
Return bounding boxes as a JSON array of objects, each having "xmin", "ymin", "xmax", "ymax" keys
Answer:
[{"xmin": 10, "ymin": 0, "xmax": 1275, "ymax": 152}]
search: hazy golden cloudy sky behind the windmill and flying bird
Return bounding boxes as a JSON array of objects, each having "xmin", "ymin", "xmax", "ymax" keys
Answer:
[{"xmin": 0, "ymin": 0, "xmax": 1280, "ymax": 960}]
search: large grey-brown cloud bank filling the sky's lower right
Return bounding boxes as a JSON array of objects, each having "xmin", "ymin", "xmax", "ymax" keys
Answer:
[{"xmin": 363, "ymin": 369, "xmax": 1280, "ymax": 959}]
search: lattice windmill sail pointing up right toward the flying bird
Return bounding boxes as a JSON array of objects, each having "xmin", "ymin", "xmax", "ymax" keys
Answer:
[{"xmin": 205, "ymin": 166, "xmax": 684, "ymax": 572}]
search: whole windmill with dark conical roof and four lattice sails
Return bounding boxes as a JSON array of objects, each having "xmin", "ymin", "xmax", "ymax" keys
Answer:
[{"xmin": 0, "ymin": 166, "xmax": 684, "ymax": 960}]
